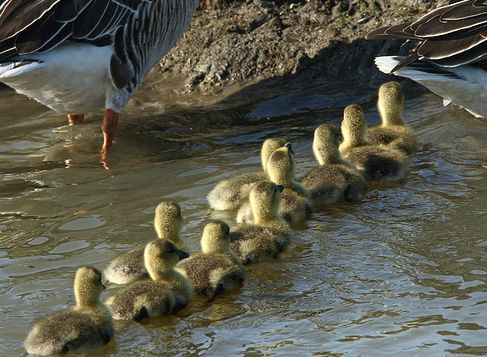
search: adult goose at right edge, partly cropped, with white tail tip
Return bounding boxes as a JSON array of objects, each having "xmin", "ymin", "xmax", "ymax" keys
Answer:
[{"xmin": 367, "ymin": 0, "xmax": 487, "ymax": 117}]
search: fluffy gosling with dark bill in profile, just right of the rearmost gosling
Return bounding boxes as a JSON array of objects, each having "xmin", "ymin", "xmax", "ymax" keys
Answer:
[{"xmin": 107, "ymin": 239, "xmax": 193, "ymax": 321}]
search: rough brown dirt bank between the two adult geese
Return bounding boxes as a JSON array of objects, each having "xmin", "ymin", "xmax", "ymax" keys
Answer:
[{"xmin": 150, "ymin": 0, "xmax": 448, "ymax": 102}]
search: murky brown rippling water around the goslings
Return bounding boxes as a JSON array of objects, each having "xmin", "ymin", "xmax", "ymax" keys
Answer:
[{"xmin": 0, "ymin": 82, "xmax": 487, "ymax": 356}]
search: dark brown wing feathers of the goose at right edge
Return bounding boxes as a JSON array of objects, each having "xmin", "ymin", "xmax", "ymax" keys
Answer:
[{"xmin": 367, "ymin": 0, "xmax": 487, "ymax": 70}]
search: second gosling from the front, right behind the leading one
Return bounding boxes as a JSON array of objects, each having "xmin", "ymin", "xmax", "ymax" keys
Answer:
[{"xmin": 339, "ymin": 104, "xmax": 407, "ymax": 181}]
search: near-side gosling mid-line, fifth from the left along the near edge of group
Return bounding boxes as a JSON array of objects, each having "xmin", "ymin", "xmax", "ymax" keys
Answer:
[{"xmin": 230, "ymin": 181, "xmax": 291, "ymax": 264}]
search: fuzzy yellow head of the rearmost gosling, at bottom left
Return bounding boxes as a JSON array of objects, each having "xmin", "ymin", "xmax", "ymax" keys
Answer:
[{"xmin": 74, "ymin": 266, "xmax": 105, "ymax": 307}]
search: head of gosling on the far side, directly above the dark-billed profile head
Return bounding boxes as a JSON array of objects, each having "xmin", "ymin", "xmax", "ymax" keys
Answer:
[{"xmin": 154, "ymin": 201, "xmax": 183, "ymax": 242}]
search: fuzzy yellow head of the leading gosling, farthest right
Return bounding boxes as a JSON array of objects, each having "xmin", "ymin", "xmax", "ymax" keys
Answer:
[{"xmin": 377, "ymin": 82, "xmax": 404, "ymax": 126}]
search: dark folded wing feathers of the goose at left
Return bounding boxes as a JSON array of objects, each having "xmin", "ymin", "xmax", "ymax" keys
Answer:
[{"xmin": 0, "ymin": 0, "xmax": 145, "ymax": 62}]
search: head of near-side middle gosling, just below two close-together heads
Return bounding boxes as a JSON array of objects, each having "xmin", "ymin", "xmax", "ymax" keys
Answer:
[{"xmin": 249, "ymin": 181, "xmax": 284, "ymax": 224}]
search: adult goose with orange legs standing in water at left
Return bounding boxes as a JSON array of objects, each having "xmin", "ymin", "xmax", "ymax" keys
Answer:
[{"xmin": 0, "ymin": 0, "xmax": 199, "ymax": 153}]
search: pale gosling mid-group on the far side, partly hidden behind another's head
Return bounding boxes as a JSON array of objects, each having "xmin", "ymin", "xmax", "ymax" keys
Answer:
[{"xmin": 208, "ymin": 138, "xmax": 286, "ymax": 211}]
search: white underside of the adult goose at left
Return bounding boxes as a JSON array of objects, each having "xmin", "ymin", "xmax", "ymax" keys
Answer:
[{"xmin": 0, "ymin": 43, "xmax": 113, "ymax": 114}]
